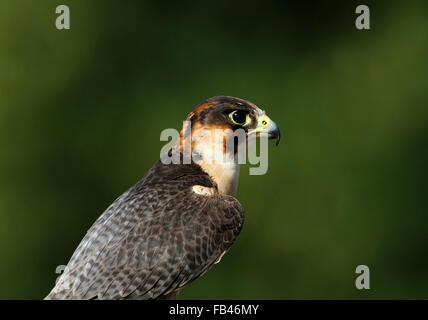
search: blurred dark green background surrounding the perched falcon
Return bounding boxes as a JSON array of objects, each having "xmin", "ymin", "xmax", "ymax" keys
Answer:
[{"xmin": 0, "ymin": 0, "xmax": 428, "ymax": 299}]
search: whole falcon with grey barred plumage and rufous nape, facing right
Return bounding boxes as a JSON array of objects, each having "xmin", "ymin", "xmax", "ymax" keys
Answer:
[{"xmin": 45, "ymin": 96, "xmax": 280, "ymax": 299}]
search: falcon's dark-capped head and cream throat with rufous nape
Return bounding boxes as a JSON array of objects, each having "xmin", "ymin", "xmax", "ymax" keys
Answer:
[{"xmin": 176, "ymin": 96, "xmax": 281, "ymax": 195}]
